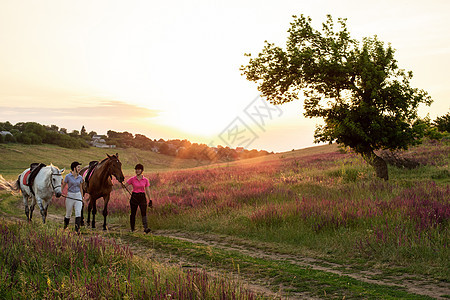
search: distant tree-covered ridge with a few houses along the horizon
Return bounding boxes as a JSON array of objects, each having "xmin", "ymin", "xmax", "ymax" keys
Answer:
[{"xmin": 0, "ymin": 122, "xmax": 273, "ymax": 161}]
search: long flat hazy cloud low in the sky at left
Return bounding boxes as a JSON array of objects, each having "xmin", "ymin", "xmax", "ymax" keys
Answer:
[{"xmin": 0, "ymin": 101, "xmax": 160, "ymax": 121}]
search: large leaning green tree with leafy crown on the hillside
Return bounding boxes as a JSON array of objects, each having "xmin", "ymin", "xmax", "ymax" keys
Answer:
[{"xmin": 241, "ymin": 15, "xmax": 432, "ymax": 180}]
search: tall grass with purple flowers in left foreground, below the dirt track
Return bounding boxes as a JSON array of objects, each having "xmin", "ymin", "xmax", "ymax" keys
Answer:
[{"xmin": 0, "ymin": 222, "xmax": 257, "ymax": 299}]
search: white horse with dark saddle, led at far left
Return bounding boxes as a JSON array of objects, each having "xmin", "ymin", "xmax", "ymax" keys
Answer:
[{"xmin": 16, "ymin": 165, "xmax": 64, "ymax": 223}]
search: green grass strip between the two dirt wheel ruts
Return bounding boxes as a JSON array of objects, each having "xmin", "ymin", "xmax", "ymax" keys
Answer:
[{"xmin": 114, "ymin": 232, "xmax": 442, "ymax": 299}]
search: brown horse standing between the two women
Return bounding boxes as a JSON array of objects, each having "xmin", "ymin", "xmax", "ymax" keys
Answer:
[{"xmin": 80, "ymin": 153, "xmax": 125, "ymax": 230}]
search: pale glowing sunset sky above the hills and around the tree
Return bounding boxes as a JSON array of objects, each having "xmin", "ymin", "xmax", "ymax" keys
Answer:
[{"xmin": 0, "ymin": 0, "xmax": 450, "ymax": 151}]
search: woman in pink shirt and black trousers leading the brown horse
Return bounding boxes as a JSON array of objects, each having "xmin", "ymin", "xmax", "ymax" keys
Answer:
[{"xmin": 127, "ymin": 164, "xmax": 151, "ymax": 233}]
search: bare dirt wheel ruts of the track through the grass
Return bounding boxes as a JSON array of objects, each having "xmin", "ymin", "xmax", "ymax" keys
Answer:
[{"xmin": 2, "ymin": 209, "xmax": 450, "ymax": 299}]
